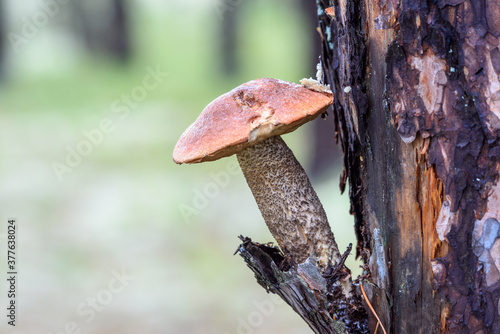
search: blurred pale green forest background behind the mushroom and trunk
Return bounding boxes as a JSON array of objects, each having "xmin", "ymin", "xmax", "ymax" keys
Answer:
[{"xmin": 0, "ymin": 0, "xmax": 359, "ymax": 334}]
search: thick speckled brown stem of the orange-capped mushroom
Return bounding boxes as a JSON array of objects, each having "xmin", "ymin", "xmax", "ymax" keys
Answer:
[{"xmin": 237, "ymin": 136, "xmax": 340, "ymax": 267}]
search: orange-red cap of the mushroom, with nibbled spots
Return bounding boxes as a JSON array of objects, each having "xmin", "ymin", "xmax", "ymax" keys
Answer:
[{"xmin": 173, "ymin": 78, "xmax": 333, "ymax": 164}]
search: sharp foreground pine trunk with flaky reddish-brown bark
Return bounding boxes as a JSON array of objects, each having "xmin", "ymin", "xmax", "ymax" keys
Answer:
[{"xmin": 319, "ymin": 0, "xmax": 500, "ymax": 334}]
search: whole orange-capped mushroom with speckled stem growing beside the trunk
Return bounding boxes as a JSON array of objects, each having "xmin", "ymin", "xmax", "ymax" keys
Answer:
[{"xmin": 173, "ymin": 78, "xmax": 340, "ymax": 268}]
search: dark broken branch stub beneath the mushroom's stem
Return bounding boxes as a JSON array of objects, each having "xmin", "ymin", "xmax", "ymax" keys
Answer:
[{"xmin": 237, "ymin": 237, "xmax": 369, "ymax": 334}]
